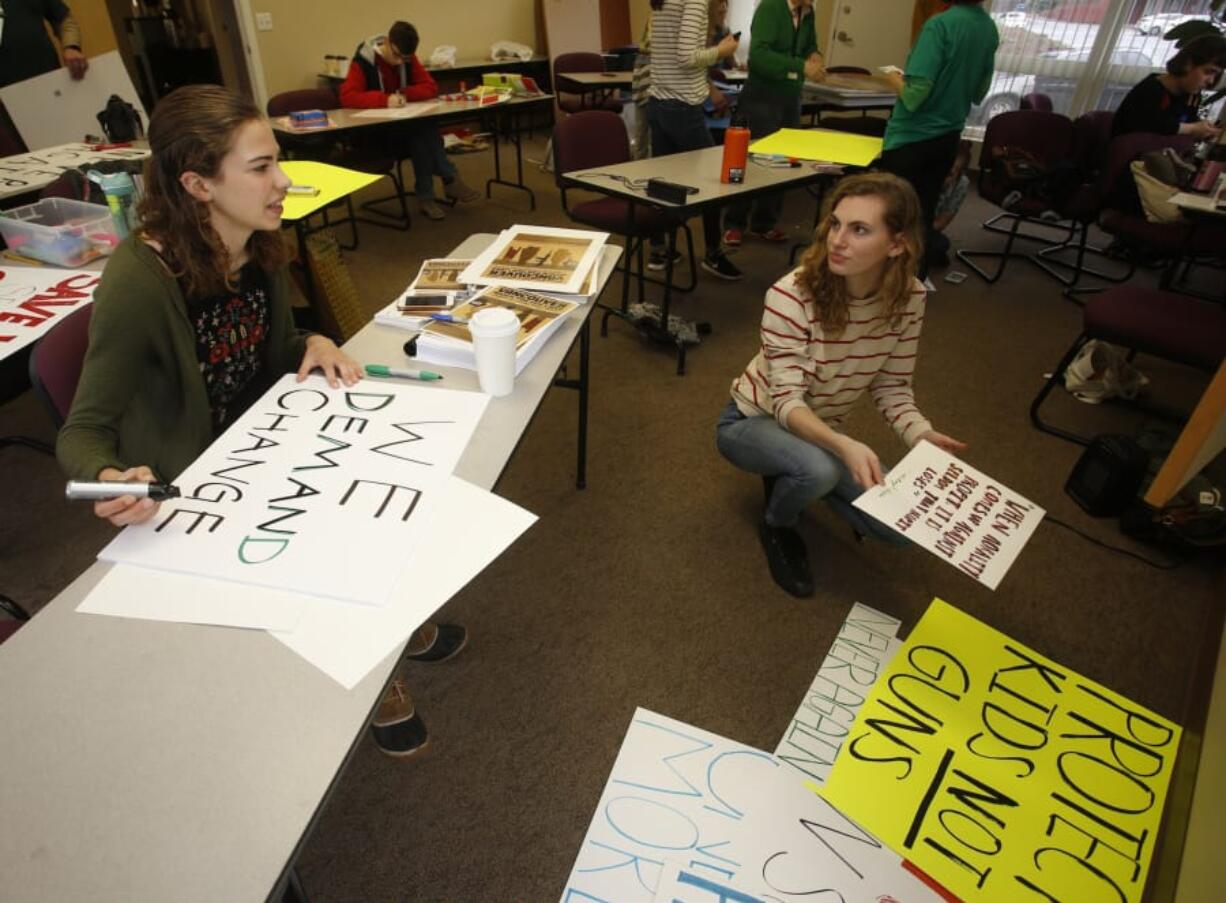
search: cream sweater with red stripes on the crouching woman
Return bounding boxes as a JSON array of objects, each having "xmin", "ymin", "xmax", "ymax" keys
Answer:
[{"xmin": 732, "ymin": 271, "xmax": 932, "ymax": 447}]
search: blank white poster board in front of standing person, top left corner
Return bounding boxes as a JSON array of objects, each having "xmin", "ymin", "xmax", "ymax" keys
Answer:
[{"xmin": 0, "ymin": 50, "xmax": 150, "ymax": 148}]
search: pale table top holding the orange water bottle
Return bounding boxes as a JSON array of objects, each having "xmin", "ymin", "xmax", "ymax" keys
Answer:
[{"xmin": 563, "ymin": 146, "xmax": 823, "ymax": 207}]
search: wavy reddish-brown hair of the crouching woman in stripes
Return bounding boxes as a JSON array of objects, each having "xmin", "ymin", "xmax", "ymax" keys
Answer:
[{"xmin": 797, "ymin": 173, "xmax": 923, "ymax": 334}]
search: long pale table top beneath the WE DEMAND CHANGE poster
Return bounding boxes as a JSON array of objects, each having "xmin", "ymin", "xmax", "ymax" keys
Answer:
[{"xmin": 0, "ymin": 235, "xmax": 622, "ymax": 903}]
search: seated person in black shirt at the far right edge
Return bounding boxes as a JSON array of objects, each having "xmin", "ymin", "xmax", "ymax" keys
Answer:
[{"xmin": 1111, "ymin": 34, "xmax": 1226, "ymax": 140}]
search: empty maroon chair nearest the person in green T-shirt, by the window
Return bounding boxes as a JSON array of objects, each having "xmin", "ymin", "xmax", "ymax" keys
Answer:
[{"xmin": 958, "ymin": 110, "xmax": 1074, "ymax": 283}]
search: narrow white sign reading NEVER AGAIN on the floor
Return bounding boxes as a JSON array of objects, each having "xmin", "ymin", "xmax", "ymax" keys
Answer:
[{"xmin": 775, "ymin": 602, "xmax": 902, "ymax": 785}]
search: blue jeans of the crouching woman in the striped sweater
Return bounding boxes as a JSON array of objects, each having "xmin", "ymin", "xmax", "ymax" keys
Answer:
[{"xmin": 715, "ymin": 401, "xmax": 907, "ymax": 545}]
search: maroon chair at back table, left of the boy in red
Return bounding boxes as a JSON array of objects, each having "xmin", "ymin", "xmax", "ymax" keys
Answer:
[{"xmin": 267, "ymin": 88, "xmax": 412, "ymax": 242}]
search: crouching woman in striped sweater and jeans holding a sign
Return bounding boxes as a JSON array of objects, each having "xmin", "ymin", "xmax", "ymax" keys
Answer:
[{"xmin": 716, "ymin": 173, "xmax": 966, "ymax": 597}]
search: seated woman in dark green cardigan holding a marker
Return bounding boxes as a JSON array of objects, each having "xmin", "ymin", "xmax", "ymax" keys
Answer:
[{"xmin": 55, "ymin": 85, "xmax": 463, "ymax": 755}]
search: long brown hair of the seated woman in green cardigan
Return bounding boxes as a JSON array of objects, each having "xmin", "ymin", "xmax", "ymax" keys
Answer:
[{"xmin": 139, "ymin": 85, "xmax": 287, "ymax": 299}]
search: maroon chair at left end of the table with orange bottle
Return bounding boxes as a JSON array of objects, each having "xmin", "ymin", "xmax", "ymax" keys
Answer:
[{"xmin": 553, "ymin": 110, "xmax": 698, "ymax": 325}]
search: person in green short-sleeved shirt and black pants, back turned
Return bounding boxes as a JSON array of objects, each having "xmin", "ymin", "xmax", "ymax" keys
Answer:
[{"xmin": 880, "ymin": 0, "xmax": 1000, "ymax": 276}]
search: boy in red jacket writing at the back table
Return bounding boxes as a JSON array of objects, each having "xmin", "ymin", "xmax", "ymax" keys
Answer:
[{"xmin": 341, "ymin": 22, "xmax": 481, "ymax": 219}]
